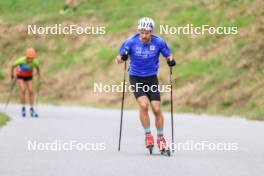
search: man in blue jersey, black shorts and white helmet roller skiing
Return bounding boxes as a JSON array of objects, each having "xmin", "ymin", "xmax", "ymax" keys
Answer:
[{"xmin": 115, "ymin": 17, "xmax": 176, "ymax": 154}]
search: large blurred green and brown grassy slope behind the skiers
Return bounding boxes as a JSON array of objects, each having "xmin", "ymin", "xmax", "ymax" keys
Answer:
[{"xmin": 0, "ymin": 0, "xmax": 264, "ymax": 120}]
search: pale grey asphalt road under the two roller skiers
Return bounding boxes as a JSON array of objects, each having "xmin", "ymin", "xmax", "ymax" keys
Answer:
[{"xmin": 0, "ymin": 105, "xmax": 264, "ymax": 176}]
